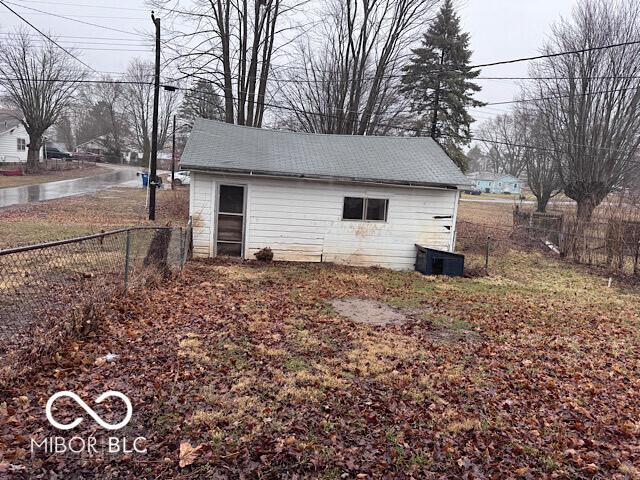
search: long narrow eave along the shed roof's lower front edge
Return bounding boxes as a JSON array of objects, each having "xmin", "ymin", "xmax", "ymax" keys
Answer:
[{"xmin": 180, "ymin": 166, "xmax": 474, "ymax": 190}]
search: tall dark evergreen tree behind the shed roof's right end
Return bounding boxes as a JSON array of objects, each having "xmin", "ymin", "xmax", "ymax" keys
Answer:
[{"xmin": 402, "ymin": 0, "xmax": 483, "ymax": 170}]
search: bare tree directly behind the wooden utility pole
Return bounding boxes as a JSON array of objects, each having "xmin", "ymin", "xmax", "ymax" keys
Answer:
[{"xmin": 125, "ymin": 59, "xmax": 178, "ymax": 163}]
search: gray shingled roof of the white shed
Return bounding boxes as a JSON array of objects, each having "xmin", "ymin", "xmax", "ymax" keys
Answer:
[{"xmin": 180, "ymin": 119, "xmax": 473, "ymax": 187}]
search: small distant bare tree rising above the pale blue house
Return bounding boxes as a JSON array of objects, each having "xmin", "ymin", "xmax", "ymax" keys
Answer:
[{"xmin": 478, "ymin": 113, "xmax": 528, "ymax": 177}]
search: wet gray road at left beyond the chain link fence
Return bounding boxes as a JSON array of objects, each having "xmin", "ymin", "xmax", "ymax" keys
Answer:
[{"xmin": 0, "ymin": 168, "xmax": 140, "ymax": 208}]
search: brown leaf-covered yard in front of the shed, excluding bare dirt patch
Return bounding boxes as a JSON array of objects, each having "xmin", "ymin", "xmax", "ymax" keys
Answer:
[{"xmin": 0, "ymin": 251, "xmax": 640, "ymax": 479}]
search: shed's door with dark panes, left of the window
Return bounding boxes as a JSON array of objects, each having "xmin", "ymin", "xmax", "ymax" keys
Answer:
[{"xmin": 216, "ymin": 185, "xmax": 245, "ymax": 257}]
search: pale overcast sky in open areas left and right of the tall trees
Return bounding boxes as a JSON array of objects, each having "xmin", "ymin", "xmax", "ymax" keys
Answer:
[{"xmin": 0, "ymin": 0, "xmax": 576, "ymax": 125}]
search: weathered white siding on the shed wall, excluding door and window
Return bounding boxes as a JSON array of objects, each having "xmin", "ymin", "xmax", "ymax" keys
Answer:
[{"xmin": 191, "ymin": 173, "xmax": 458, "ymax": 269}]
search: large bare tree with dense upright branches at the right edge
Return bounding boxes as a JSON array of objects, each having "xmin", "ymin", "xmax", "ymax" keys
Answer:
[{"xmin": 531, "ymin": 0, "xmax": 640, "ymax": 224}]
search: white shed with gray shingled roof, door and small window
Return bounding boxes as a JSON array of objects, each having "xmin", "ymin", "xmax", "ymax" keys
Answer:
[{"xmin": 181, "ymin": 120, "xmax": 471, "ymax": 269}]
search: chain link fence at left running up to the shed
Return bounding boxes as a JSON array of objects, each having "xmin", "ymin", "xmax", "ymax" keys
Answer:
[{"xmin": 0, "ymin": 225, "xmax": 191, "ymax": 358}]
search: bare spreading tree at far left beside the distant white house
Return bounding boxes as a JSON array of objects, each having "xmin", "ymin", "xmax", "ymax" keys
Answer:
[{"xmin": 0, "ymin": 30, "xmax": 84, "ymax": 172}]
